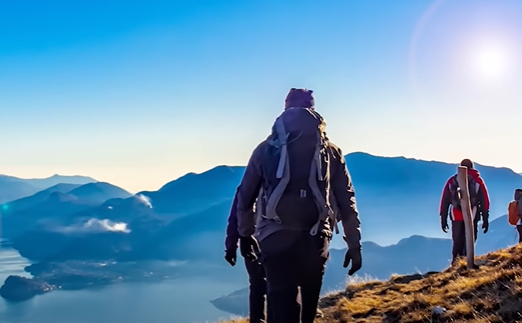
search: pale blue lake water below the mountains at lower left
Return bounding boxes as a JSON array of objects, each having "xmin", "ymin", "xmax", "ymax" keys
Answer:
[{"xmin": 0, "ymin": 247, "xmax": 247, "ymax": 323}]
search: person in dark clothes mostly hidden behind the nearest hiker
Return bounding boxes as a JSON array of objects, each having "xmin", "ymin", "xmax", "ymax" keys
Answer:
[{"xmin": 225, "ymin": 186, "xmax": 266, "ymax": 323}]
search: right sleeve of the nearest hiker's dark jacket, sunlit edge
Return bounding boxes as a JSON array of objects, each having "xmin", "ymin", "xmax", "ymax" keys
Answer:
[{"xmin": 331, "ymin": 145, "xmax": 361, "ymax": 249}]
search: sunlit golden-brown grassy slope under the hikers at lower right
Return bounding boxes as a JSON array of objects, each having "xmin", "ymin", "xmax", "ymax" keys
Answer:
[{"xmin": 221, "ymin": 245, "xmax": 522, "ymax": 323}]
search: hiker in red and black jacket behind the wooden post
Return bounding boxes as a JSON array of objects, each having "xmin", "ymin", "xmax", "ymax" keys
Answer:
[{"xmin": 440, "ymin": 159, "xmax": 489, "ymax": 263}]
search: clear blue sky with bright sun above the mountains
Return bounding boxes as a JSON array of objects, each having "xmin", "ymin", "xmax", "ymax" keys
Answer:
[{"xmin": 0, "ymin": 0, "xmax": 522, "ymax": 191}]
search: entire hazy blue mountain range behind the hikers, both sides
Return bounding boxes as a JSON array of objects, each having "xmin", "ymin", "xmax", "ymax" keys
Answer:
[{"xmin": 1, "ymin": 153, "xmax": 522, "ymax": 306}]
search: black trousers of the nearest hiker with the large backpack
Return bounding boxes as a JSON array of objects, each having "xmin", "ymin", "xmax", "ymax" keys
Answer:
[{"xmin": 261, "ymin": 231, "xmax": 329, "ymax": 323}]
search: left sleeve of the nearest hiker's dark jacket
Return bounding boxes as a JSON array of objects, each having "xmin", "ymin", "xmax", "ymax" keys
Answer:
[{"xmin": 237, "ymin": 143, "xmax": 265, "ymax": 237}]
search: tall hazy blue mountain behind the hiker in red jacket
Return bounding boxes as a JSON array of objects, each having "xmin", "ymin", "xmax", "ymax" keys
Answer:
[{"xmin": 340, "ymin": 153, "xmax": 522, "ymax": 244}]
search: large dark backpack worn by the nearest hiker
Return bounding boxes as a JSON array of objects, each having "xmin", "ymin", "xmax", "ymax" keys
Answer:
[{"xmin": 264, "ymin": 108, "xmax": 325, "ymax": 230}]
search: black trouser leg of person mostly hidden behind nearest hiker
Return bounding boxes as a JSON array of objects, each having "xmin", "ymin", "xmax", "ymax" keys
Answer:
[{"xmin": 245, "ymin": 259, "xmax": 266, "ymax": 323}]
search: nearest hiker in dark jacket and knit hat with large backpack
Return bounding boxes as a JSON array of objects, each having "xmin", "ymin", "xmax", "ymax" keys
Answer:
[{"xmin": 237, "ymin": 89, "xmax": 362, "ymax": 323}]
